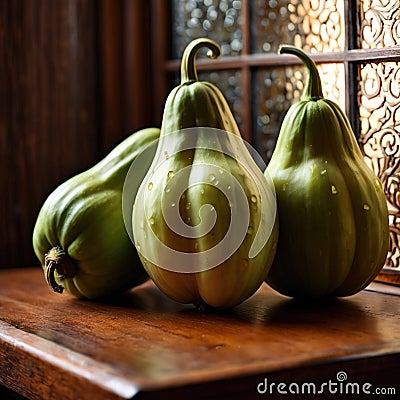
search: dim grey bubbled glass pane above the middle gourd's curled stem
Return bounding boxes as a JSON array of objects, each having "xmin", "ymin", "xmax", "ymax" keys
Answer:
[{"xmin": 171, "ymin": 0, "xmax": 243, "ymax": 58}]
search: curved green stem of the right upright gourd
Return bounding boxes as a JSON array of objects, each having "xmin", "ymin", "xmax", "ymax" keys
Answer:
[{"xmin": 278, "ymin": 45, "xmax": 324, "ymax": 100}]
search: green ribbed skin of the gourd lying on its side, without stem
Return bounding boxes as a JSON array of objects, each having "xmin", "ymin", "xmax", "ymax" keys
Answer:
[{"xmin": 33, "ymin": 128, "xmax": 160, "ymax": 298}]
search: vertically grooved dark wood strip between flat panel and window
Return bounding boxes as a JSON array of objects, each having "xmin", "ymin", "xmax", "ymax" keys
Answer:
[{"xmin": 98, "ymin": 0, "xmax": 155, "ymax": 153}]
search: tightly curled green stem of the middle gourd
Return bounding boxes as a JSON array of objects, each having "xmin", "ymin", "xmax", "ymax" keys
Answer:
[{"xmin": 181, "ymin": 38, "xmax": 221, "ymax": 84}]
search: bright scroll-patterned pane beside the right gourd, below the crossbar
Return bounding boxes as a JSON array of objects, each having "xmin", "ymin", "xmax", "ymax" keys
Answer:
[{"xmin": 359, "ymin": 62, "xmax": 400, "ymax": 268}]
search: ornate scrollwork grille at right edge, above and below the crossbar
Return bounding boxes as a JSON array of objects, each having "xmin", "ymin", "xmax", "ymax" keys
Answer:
[{"xmin": 358, "ymin": 0, "xmax": 400, "ymax": 272}]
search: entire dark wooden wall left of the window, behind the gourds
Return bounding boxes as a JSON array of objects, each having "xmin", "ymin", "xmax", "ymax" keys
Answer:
[{"xmin": 0, "ymin": 0, "xmax": 161, "ymax": 268}]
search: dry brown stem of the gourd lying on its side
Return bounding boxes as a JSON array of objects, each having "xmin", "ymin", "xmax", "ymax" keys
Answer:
[{"xmin": 44, "ymin": 247, "xmax": 76, "ymax": 293}]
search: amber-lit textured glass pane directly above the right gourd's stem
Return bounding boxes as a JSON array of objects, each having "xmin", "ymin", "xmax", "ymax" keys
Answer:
[{"xmin": 251, "ymin": 0, "xmax": 345, "ymax": 53}]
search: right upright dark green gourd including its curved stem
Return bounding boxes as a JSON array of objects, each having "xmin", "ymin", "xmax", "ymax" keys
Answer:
[{"xmin": 267, "ymin": 46, "xmax": 389, "ymax": 298}]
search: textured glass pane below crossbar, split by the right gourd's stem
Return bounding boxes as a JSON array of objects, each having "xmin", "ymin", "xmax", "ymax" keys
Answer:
[{"xmin": 253, "ymin": 64, "xmax": 345, "ymax": 162}]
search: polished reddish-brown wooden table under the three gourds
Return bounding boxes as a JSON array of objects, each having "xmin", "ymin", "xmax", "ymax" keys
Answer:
[{"xmin": 0, "ymin": 268, "xmax": 400, "ymax": 400}]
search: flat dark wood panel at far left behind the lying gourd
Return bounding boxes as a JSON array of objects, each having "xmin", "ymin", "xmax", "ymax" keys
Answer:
[{"xmin": 0, "ymin": 0, "xmax": 100, "ymax": 267}]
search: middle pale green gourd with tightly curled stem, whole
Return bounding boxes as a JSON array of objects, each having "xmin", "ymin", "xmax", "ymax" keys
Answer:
[{"xmin": 132, "ymin": 38, "xmax": 278, "ymax": 308}]
